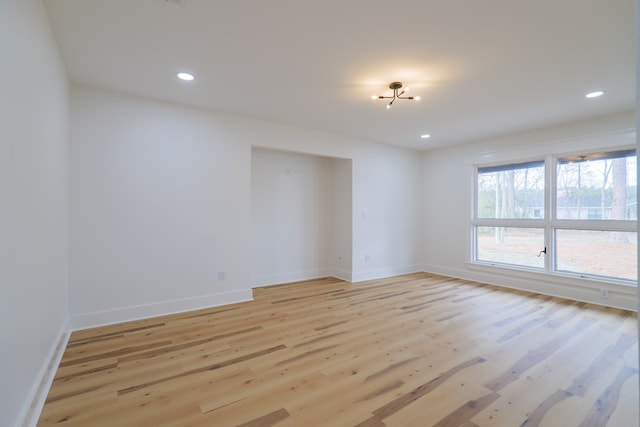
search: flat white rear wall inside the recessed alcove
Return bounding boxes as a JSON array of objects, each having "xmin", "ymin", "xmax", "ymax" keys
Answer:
[{"xmin": 251, "ymin": 149, "xmax": 333, "ymax": 286}]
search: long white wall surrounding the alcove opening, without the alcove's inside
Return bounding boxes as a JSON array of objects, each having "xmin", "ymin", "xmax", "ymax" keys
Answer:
[{"xmin": 70, "ymin": 85, "xmax": 421, "ymax": 327}]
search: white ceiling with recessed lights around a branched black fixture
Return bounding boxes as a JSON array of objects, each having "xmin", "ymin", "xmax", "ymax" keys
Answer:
[{"xmin": 45, "ymin": 0, "xmax": 635, "ymax": 149}]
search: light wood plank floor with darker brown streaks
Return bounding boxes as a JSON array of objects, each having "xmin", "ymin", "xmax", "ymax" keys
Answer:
[{"xmin": 38, "ymin": 273, "xmax": 639, "ymax": 427}]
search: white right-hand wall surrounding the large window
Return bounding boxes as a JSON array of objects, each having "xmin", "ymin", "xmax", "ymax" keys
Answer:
[{"xmin": 422, "ymin": 112, "xmax": 636, "ymax": 309}]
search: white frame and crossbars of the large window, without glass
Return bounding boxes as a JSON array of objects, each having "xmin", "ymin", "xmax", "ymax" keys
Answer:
[{"xmin": 469, "ymin": 146, "xmax": 638, "ymax": 286}]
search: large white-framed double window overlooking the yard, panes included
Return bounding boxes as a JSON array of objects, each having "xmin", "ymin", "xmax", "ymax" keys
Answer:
[{"xmin": 472, "ymin": 150, "xmax": 637, "ymax": 283}]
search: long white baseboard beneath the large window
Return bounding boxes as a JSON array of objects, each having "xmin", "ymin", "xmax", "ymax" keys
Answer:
[{"xmin": 423, "ymin": 264, "xmax": 638, "ymax": 311}]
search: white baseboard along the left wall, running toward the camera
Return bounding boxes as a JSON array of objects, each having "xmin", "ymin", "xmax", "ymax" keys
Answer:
[{"xmin": 18, "ymin": 322, "xmax": 71, "ymax": 427}]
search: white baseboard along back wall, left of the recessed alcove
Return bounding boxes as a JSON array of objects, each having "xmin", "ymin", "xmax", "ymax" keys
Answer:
[{"xmin": 70, "ymin": 289, "xmax": 253, "ymax": 331}]
